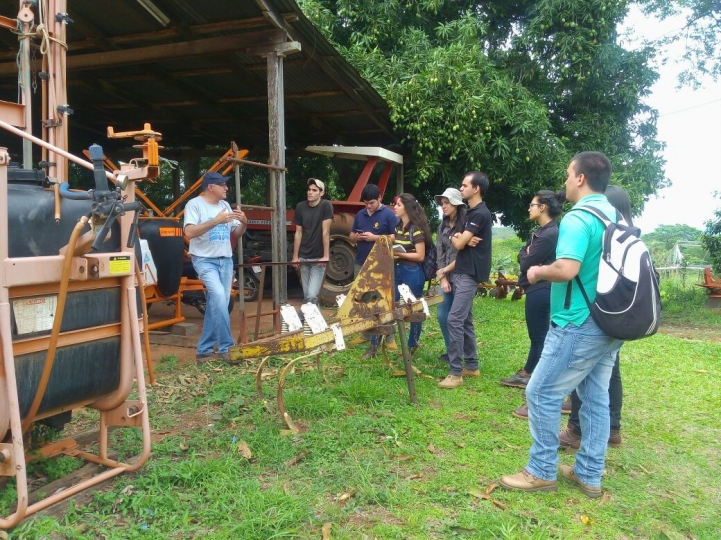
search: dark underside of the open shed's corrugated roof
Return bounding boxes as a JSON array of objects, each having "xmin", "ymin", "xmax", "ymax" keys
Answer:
[{"xmin": 0, "ymin": 0, "xmax": 397, "ymax": 159}]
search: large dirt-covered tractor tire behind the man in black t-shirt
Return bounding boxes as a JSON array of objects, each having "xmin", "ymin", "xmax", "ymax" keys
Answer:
[{"xmin": 318, "ymin": 213, "xmax": 356, "ymax": 306}]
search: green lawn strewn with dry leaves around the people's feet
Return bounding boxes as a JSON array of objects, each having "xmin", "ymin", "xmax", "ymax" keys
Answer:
[{"xmin": 11, "ymin": 293, "xmax": 721, "ymax": 540}]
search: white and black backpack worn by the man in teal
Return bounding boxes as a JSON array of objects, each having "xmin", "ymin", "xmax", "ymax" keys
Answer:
[{"xmin": 565, "ymin": 206, "xmax": 661, "ymax": 341}]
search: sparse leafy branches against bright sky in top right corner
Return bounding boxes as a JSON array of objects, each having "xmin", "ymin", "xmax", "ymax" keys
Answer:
[{"xmin": 638, "ymin": 0, "xmax": 721, "ymax": 87}]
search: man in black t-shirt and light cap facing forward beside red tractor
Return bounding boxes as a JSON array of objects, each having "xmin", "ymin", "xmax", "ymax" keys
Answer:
[{"xmin": 291, "ymin": 178, "xmax": 333, "ymax": 304}]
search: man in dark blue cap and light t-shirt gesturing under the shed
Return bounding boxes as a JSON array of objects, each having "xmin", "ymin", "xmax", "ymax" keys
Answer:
[{"xmin": 183, "ymin": 172, "xmax": 248, "ymax": 364}]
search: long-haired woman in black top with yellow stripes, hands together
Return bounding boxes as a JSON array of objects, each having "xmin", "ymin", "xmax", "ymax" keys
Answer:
[{"xmin": 363, "ymin": 193, "xmax": 432, "ymax": 358}]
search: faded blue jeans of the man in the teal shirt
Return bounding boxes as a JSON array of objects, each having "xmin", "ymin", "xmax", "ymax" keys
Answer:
[{"xmin": 526, "ymin": 316, "xmax": 623, "ymax": 487}]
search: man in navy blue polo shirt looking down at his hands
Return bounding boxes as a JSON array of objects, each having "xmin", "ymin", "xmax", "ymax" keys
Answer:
[{"xmin": 349, "ymin": 184, "xmax": 398, "ymax": 350}]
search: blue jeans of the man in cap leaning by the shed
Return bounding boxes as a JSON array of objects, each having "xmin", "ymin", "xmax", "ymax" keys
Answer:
[{"xmin": 191, "ymin": 255, "xmax": 235, "ymax": 355}]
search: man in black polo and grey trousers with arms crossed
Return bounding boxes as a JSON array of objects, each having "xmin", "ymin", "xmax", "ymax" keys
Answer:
[{"xmin": 438, "ymin": 171, "xmax": 493, "ymax": 390}]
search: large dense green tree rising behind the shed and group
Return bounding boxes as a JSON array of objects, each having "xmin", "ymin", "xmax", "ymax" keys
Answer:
[{"xmin": 299, "ymin": 0, "xmax": 665, "ymax": 233}]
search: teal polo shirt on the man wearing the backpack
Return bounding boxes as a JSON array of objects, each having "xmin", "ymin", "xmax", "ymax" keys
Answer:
[{"xmin": 551, "ymin": 193, "xmax": 616, "ymax": 327}]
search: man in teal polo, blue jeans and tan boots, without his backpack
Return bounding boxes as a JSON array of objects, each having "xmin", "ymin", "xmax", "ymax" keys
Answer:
[{"xmin": 500, "ymin": 152, "xmax": 623, "ymax": 498}]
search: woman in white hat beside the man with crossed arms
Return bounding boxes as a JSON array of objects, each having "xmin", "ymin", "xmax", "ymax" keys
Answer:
[{"xmin": 435, "ymin": 188, "xmax": 466, "ymax": 362}]
